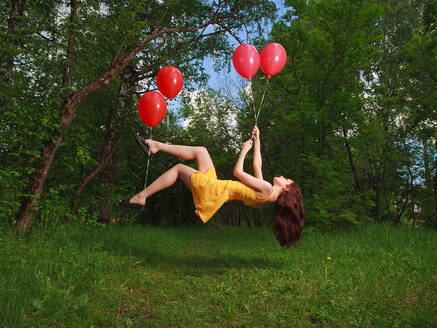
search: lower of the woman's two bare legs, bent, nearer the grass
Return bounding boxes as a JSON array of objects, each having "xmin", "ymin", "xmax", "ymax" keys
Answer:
[{"xmin": 126, "ymin": 164, "xmax": 197, "ymax": 205}]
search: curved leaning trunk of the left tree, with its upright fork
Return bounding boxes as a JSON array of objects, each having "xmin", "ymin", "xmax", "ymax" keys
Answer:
[{"xmin": 16, "ymin": 5, "xmax": 223, "ymax": 230}]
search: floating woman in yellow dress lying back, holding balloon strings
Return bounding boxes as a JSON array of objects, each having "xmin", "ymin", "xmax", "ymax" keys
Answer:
[{"xmin": 120, "ymin": 126, "xmax": 305, "ymax": 247}]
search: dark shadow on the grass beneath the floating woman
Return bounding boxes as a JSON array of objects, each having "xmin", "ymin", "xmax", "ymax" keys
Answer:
[{"xmin": 58, "ymin": 226, "xmax": 290, "ymax": 276}]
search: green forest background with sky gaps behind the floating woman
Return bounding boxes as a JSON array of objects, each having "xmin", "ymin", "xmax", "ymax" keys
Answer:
[{"xmin": 0, "ymin": 0, "xmax": 437, "ymax": 229}]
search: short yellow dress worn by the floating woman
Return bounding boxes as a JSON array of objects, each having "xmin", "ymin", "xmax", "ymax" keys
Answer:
[{"xmin": 191, "ymin": 166, "xmax": 273, "ymax": 223}]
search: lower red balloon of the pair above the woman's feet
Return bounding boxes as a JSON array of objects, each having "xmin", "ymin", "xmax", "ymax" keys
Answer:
[{"xmin": 138, "ymin": 91, "xmax": 167, "ymax": 128}]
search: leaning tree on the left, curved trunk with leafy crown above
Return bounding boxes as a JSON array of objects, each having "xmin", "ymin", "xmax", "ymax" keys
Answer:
[{"xmin": 2, "ymin": 0, "xmax": 271, "ymax": 229}]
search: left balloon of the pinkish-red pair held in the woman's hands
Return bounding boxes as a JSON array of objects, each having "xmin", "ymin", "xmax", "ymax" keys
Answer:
[{"xmin": 232, "ymin": 44, "xmax": 259, "ymax": 80}]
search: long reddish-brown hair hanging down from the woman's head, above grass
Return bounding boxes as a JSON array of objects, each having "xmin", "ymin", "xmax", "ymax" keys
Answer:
[{"xmin": 273, "ymin": 182, "xmax": 305, "ymax": 248}]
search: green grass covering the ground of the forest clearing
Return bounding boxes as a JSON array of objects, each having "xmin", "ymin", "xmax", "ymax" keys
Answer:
[{"xmin": 0, "ymin": 224, "xmax": 437, "ymax": 327}]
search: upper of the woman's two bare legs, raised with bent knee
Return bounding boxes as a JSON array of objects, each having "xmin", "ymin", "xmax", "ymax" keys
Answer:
[{"xmin": 146, "ymin": 139, "xmax": 214, "ymax": 172}]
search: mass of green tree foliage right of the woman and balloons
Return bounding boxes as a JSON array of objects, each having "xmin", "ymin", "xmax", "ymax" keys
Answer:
[{"xmin": 242, "ymin": 0, "xmax": 437, "ymax": 224}]
